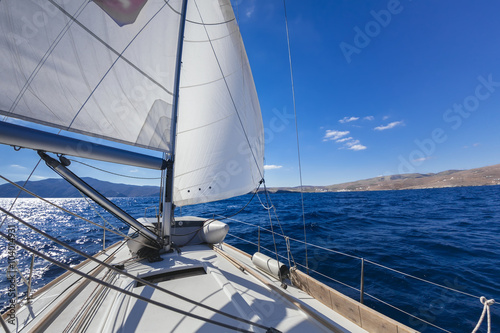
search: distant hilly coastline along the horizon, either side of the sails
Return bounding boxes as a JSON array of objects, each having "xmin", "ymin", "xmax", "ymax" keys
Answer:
[{"xmin": 0, "ymin": 164, "xmax": 500, "ymax": 198}]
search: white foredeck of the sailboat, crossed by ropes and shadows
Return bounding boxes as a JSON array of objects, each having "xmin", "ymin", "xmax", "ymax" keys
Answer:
[{"xmin": 7, "ymin": 243, "xmax": 367, "ymax": 333}]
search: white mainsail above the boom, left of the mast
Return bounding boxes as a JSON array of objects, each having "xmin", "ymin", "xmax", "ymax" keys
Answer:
[{"xmin": 0, "ymin": 0, "xmax": 180, "ymax": 152}]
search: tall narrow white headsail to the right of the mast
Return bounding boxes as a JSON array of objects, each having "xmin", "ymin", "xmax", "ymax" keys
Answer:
[{"xmin": 174, "ymin": 0, "xmax": 264, "ymax": 206}]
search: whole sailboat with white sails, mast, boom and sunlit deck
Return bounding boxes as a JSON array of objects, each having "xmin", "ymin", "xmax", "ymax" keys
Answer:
[{"xmin": 0, "ymin": 0, "xmax": 422, "ymax": 333}]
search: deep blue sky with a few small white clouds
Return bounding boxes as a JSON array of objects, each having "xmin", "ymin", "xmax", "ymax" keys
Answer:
[{"xmin": 0, "ymin": 0, "xmax": 500, "ymax": 186}]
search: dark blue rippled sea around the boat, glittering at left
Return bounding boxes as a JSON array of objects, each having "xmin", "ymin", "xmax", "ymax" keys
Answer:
[{"xmin": 0, "ymin": 186, "xmax": 500, "ymax": 332}]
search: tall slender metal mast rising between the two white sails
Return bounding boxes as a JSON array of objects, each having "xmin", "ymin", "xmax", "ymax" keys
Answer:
[{"xmin": 161, "ymin": 0, "xmax": 187, "ymax": 251}]
